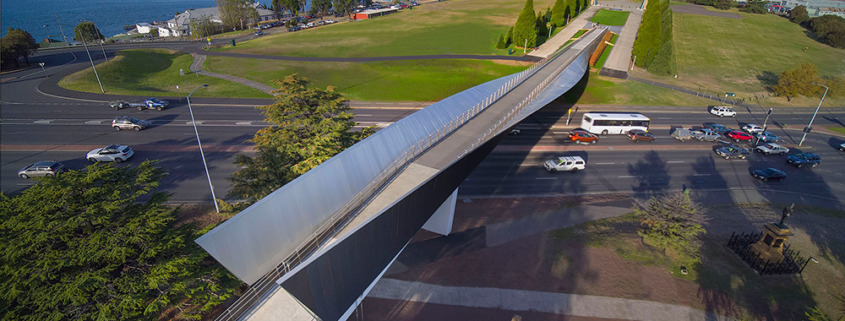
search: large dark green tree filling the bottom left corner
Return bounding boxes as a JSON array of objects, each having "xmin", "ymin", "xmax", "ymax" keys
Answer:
[{"xmin": 0, "ymin": 161, "xmax": 240, "ymax": 321}]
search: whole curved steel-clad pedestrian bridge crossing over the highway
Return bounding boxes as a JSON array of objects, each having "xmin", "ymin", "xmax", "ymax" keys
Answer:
[{"xmin": 196, "ymin": 29, "xmax": 607, "ymax": 320}]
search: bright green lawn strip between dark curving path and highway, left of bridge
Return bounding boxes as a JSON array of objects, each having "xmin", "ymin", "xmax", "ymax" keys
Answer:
[{"xmin": 204, "ymin": 56, "xmax": 525, "ymax": 101}]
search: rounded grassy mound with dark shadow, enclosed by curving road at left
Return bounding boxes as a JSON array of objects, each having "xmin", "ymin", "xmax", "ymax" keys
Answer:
[{"xmin": 59, "ymin": 49, "xmax": 271, "ymax": 98}]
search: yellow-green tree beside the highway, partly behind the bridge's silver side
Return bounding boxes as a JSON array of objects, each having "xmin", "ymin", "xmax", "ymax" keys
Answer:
[{"xmin": 229, "ymin": 74, "xmax": 372, "ymax": 201}]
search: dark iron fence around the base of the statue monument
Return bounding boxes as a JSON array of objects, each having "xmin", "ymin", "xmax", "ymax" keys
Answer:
[{"xmin": 728, "ymin": 232, "xmax": 809, "ymax": 275}]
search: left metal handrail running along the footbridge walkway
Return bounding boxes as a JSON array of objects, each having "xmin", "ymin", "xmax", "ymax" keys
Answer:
[{"xmin": 215, "ymin": 30, "xmax": 588, "ymax": 321}]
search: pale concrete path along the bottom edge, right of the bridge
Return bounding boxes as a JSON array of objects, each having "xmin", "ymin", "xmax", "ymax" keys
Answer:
[{"xmin": 367, "ymin": 279, "xmax": 732, "ymax": 321}]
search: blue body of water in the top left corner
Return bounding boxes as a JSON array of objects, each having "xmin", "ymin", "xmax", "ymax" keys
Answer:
[{"xmin": 0, "ymin": 0, "xmax": 219, "ymax": 42}]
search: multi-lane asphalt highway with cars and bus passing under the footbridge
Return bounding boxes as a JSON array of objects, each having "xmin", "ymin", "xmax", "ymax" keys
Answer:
[{"xmin": 0, "ymin": 46, "xmax": 845, "ymax": 202}]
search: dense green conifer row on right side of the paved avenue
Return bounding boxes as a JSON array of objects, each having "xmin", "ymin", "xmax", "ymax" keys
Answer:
[{"xmin": 632, "ymin": 0, "xmax": 677, "ymax": 75}]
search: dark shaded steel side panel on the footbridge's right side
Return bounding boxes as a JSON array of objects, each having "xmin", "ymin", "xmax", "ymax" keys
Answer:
[{"xmin": 281, "ymin": 134, "xmax": 504, "ymax": 321}]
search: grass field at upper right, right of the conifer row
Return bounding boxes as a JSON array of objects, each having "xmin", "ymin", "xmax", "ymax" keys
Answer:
[{"xmin": 635, "ymin": 9, "xmax": 845, "ymax": 106}]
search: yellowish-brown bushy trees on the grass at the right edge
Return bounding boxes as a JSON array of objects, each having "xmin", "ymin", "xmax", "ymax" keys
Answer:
[{"xmin": 772, "ymin": 63, "xmax": 845, "ymax": 101}]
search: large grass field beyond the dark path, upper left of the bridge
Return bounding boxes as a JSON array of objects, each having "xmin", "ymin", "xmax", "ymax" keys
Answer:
[{"xmin": 218, "ymin": 0, "xmax": 568, "ymax": 57}]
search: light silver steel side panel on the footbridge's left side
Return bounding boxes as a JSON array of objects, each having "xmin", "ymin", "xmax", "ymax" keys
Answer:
[{"xmin": 196, "ymin": 75, "xmax": 516, "ymax": 284}]
